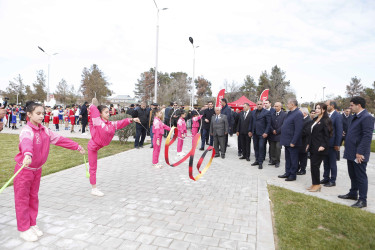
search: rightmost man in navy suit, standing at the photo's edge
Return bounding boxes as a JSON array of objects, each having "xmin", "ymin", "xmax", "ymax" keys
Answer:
[{"xmin": 338, "ymin": 96, "xmax": 374, "ymax": 208}]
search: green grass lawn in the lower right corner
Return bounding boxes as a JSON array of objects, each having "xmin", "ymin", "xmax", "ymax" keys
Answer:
[{"xmin": 268, "ymin": 186, "xmax": 375, "ymax": 249}]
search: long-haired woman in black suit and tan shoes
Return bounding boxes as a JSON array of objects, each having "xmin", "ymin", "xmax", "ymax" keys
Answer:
[{"xmin": 306, "ymin": 103, "xmax": 333, "ymax": 192}]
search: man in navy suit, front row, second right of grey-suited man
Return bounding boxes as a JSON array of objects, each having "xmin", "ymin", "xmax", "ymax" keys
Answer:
[{"xmin": 249, "ymin": 101, "xmax": 271, "ymax": 169}]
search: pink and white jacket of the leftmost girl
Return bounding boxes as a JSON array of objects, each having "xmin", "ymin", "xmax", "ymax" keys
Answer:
[{"xmin": 14, "ymin": 122, "xmax": 81, "ymax": 168}]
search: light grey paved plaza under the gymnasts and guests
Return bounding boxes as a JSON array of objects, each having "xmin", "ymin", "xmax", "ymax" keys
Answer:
[{"xmin": 0, "ymin": 130, "xmax": 375, "ymax": 249}]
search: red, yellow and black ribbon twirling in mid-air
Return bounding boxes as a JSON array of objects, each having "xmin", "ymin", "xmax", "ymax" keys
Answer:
[{"xmin": 164, "ymin": 127, "xmax": 215, "ymax": 181}]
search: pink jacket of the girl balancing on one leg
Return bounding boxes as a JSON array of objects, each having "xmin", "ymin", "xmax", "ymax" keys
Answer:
[{"xmin": 89, "ymin": 105, "xmax": 132, "ymax": 148}]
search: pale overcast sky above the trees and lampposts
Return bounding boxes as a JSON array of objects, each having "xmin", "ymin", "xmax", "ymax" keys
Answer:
[{"xmin": 0, "ymin": 0, "xmax": 375, "ymax": 101}]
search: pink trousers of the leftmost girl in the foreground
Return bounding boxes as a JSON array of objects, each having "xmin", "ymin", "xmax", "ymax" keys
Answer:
[{"xmin": 13, "ymin": 164, "xmax": 42, "ymax": 232}]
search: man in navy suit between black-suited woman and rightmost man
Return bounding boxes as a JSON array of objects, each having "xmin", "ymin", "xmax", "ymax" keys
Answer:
[{"xmin": 320, "ymin": 100, "xmax": 343, "ymax": 187}]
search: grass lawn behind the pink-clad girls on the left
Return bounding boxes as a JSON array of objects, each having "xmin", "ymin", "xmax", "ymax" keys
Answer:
[{"xmin": 0, "ymin": 134, "xmax": 134, "ymax": 187}]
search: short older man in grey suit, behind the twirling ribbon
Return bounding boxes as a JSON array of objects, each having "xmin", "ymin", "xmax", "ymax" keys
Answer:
[{"xmin": 210, "ymin": 107, "xmax": 229, "ymax": 159}]
